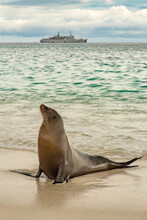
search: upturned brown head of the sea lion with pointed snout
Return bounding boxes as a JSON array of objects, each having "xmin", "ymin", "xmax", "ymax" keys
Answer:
[{"xmin": 40, "ymin": 104, "xmax": 64, "ymax": 132}]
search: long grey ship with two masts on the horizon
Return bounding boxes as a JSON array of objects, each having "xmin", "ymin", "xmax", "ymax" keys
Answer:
[{"xmin": 40, "ymin": 32, "xmax": 87, "ymax": 43}]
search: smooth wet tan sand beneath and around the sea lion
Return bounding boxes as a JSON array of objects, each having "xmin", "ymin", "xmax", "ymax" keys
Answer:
[{"xmin": 0, "ymin": 148, "xmax": 147, "ymax": 220}]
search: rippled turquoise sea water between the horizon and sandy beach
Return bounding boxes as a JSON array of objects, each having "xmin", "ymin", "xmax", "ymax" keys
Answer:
[{"xmin": 0, "ymin": 43, "xmax": 147, "ymax": 157}]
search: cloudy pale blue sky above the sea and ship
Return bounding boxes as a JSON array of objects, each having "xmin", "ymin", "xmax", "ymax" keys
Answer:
[{"xmin": 0, "ymin": 0, "xmax": 147, "ymax": 42}]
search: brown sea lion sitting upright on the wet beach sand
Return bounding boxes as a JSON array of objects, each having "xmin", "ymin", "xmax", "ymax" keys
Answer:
[{"xmin": 13, "ymin": 104, "xmax": 141, "ymax": 184}]
